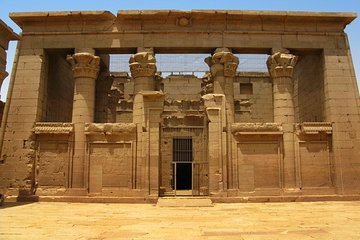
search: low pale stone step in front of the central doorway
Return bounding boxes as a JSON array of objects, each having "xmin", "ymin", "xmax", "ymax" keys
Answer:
[{"xmin": 157, "ymin": 197, "xmax": 214, "ymax": 207}]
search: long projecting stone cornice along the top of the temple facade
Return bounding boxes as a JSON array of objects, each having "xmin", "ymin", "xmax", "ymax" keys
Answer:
[{"xmin": 10, "ymin": 10, "xmax": 357, "ymax": 32}]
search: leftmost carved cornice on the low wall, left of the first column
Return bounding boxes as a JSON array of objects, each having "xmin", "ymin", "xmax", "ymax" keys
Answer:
[{"xmin": 33, "ymin": 122, "xmax": 74, "ymax": 135}]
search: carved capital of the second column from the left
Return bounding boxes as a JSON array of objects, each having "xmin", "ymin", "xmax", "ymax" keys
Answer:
[{"xmin": 129, "ymin": 52, "xmax": 156, "ymax": 78}]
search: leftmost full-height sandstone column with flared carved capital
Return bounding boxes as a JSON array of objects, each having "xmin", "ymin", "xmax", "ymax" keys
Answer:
[{"xmin": 68, "ymin": 52, "xmax": 100, "ymax": 189}]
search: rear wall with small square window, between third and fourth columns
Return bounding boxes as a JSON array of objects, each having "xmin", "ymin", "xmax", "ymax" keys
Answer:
[{"xmin": 234, "ymin": 72, "xmax": 274, "ymax": 123}]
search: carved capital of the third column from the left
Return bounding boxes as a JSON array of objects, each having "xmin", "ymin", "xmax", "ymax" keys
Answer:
[{"xmin": 205, "ymin": 48, "xmax": 239, "ymax": 77}]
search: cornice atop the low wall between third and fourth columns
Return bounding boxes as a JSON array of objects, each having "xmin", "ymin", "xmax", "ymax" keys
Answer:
[{"xmin": 231, "ymin": 123, "xmax": 283, "ymax": 136}]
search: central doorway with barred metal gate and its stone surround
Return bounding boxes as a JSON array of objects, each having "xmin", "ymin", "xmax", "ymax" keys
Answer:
[{"xmin": 160, "ymin": 127, "xmax": 209, "ymax": 196}]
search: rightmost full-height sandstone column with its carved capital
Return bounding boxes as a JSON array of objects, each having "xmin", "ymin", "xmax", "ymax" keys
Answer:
[{"xmin": 267, "ymin": 49, "xmax": 298, "ymax": 192}]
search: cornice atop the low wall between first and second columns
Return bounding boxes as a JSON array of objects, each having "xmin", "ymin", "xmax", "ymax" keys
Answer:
[{"xmin": 85, "ymin": 123, "xmax": 136, "ymax": 135}]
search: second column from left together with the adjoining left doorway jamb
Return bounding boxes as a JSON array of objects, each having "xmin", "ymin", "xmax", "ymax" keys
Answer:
[{"xmin": 129, "ymin": 49, "xmax": 164, "ymax": 198}]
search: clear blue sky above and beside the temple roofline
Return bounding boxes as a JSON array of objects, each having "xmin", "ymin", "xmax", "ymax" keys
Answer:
[{"xmin": 0, "ymin": 0, "xmax": 360, "ymax": 101}]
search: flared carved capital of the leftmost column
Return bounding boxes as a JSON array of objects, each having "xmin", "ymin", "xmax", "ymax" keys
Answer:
[{"xmin": 67, "ymin": 53, "xmax": 100, "ymax": 79}]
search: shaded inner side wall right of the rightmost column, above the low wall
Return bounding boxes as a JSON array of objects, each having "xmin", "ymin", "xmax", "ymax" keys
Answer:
[{"xmin": 294, "ymin": 54, "xmax": 325, "ymax": 122}]
